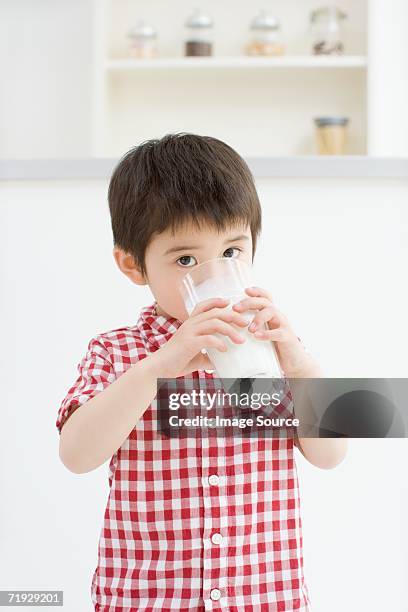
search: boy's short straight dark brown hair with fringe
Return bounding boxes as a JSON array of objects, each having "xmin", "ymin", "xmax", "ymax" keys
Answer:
[{"xmin": 108, "ymin": 133, "xmax": 261, "ymax": 274}]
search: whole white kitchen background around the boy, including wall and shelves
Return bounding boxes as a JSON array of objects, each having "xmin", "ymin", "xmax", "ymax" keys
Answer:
[{"xmin": 0, "ymin": 0, "xmax": 408, "ymax": 612}]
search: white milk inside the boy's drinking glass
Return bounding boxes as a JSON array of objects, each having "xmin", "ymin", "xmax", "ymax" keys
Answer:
[{"xmin": 186, "ymin": 290, "xmax": 282, "ymax": 378}]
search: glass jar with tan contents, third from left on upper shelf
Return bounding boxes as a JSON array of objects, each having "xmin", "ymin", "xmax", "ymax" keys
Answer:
[{"xmin": 246, "ymin": 11, "xmax": 284, "ymax": 56}]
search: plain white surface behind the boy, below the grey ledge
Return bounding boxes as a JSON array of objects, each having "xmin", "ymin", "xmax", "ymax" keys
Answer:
[{"xmin": 0, "ymin": 178, "xmax": 408, "ymax": 612}]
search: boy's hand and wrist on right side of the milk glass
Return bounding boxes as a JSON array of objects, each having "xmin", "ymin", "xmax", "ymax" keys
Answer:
[{"xmin": 233, "ymin": 287, "xmax": 315, "ymax": 377}]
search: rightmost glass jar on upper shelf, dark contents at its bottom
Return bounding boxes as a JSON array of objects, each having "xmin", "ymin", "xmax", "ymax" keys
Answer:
[{"xmin": 310, "ymin": 6, "xmax": 347, "ymax": 55}]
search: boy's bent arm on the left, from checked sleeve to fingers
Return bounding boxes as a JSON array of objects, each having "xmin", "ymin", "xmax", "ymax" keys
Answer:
[{"xmin": 58, "ymin": 298, "xmax": 248, "ymax": 474}]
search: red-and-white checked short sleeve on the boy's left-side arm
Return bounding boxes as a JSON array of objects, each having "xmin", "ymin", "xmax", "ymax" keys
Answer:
[{"xmin": 55, "ymin": 337, "xmax": 116, "ymax": 434}]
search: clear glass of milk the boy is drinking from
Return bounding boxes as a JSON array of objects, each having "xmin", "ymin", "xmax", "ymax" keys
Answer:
[{"xmin": 179, "ymin": 257, "xmax": 284, "ymax": 378}]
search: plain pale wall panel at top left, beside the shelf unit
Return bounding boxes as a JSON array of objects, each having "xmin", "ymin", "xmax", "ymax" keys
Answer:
[{"xmin": 0, "ymin": 0, "xmax": 92, "ymax": 158}]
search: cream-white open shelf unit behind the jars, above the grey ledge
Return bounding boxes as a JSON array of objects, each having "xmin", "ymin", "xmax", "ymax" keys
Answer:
[{"xmin": 93, "ymin": 0, "xmax": 408, "ymax": 157}]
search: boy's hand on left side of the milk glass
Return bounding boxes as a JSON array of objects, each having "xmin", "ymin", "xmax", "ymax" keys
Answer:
[{"xmin": 153, "ymin": 298, "xmax": 248, "ymax": 378}]
